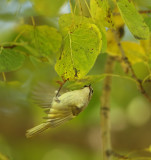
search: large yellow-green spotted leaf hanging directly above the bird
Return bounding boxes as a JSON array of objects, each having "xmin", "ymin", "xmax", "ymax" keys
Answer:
[{"xmin": 55, "ymin": 15, "xmax": 102, "ymax": 80}]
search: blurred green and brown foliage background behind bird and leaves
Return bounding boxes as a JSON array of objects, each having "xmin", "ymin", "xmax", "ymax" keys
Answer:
[{"xmin": 0, "ymin": 0, "xmax": 151, "ymax": 160}]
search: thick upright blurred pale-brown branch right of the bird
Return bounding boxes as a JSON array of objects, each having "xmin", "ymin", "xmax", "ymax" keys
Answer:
[{"xmin": 100, "ymin": 56, "xmax": 114, "ymax": 160}]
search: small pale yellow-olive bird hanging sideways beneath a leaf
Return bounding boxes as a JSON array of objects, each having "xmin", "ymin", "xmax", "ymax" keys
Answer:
[{"xmin": 26, "ymin": 85, "xmax": 93, "ymax": 138}]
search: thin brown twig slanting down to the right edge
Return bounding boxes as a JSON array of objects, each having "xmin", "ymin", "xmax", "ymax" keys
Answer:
[{"xmin": 112, "ymin": 30, "xmax": 151, "ymax": 103}]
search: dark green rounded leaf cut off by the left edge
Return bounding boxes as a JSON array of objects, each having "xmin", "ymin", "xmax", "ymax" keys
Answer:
[{"xmin": 0, "ymin": 49, "xmax": 25, "ymax": 72}]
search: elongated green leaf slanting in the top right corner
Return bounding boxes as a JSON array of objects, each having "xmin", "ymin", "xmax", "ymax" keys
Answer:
[{"xmin": 117, "ymin": 0, "xmax": 149, "ymax": 39}]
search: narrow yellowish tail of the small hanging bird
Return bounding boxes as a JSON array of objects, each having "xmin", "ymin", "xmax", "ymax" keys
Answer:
[{"xmin": 26, "ymin": 122, "xmax": 50, "ymax": 138}]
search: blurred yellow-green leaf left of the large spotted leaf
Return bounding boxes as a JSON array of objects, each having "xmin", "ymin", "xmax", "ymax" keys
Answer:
[{"xmin": 19, "ymin": 25, "xmax": 62, "ymax": 57}]
